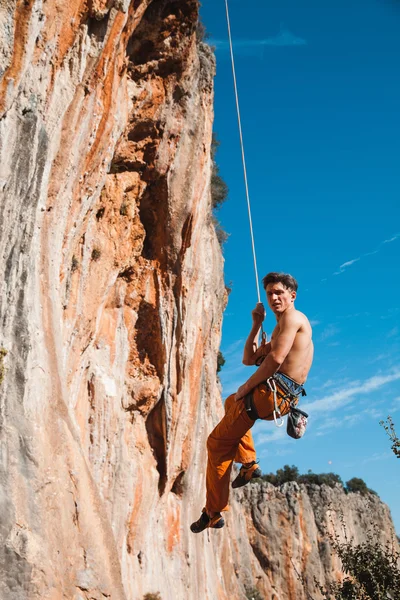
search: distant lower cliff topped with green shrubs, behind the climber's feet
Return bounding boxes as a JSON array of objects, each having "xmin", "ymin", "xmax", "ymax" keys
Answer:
[{"xmin": 236, "ymin": 482, "xmax": 398, "ymax": 600}]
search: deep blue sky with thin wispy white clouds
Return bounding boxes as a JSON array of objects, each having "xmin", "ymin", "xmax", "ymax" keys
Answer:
[{"xmin": 201, "ymin": 0, "xmax": 400, "ymax": 532}]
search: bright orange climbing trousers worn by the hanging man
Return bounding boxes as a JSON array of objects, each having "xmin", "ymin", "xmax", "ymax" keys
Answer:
[{"xmin": 206, "ymin": 383, "xmax": 290, "ymax": 512}]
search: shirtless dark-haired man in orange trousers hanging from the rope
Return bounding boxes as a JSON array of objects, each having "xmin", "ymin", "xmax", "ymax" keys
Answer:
[{"xmin": 190, "ymin": 273, "xmax": 314, "ymax": 533}]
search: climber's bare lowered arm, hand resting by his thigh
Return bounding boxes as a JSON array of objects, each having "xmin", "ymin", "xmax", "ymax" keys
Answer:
[{"xmin": 235, "ymin": 313, "xmax": 301, "ymax": 400}]
